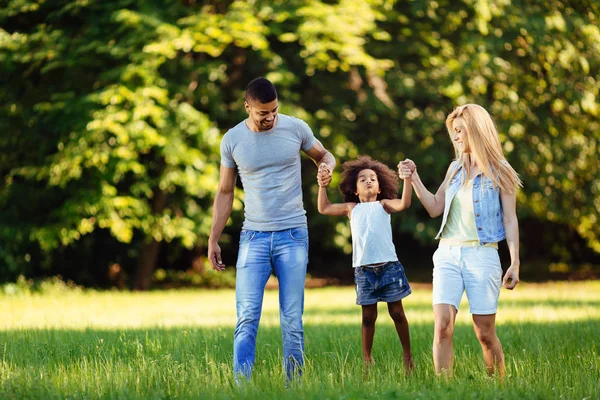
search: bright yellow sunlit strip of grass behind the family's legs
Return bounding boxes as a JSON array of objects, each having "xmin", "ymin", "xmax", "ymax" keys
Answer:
[{"xmin": 0, "ymin": 281, "xmax": 600, "ymax": 330}]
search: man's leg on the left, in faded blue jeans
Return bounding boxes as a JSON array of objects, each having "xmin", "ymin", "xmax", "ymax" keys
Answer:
[{"xmin": 233, "ymin": 231, "xmax": 272, "ymax": 380}]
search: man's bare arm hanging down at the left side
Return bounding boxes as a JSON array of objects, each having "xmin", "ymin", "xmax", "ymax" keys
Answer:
[{"xmin": 208, "ymin": 165, "xmax": 237, "ymax": 271}]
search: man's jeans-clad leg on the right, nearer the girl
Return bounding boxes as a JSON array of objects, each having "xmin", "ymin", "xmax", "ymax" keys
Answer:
[{"xmin": 273, "ymin": 228, "xmax": 308, "ymax": 380}]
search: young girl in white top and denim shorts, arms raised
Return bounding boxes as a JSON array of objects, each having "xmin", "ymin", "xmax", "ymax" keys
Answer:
[{"xmin": 317, "ymin": 156, "xmax": 414, "ymax": 372}]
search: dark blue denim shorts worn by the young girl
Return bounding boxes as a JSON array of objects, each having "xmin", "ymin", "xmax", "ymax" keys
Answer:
[{"xmin": 354, "ymin": 261, "xmax": 412, "ymax": 306}]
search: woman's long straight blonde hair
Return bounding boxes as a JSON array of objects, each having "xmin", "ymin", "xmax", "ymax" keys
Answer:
[{"xmin": 446, "ymin": 104, "xmax": 523, "ymax": 193}]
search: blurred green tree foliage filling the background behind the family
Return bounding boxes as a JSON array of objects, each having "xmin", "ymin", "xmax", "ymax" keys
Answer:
[{"xmin": 0, "ymin": 0, "xmax": 600, "ymax": 281}]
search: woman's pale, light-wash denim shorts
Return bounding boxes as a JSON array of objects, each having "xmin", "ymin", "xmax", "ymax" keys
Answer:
[{"xmin": 433, "ymin": 245, "xmax": 502, "ymax": 315}]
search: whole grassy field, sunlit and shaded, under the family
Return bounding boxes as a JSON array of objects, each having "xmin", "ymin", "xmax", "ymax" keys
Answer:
[{"xmin": 0, "ymin": 282, "xmax": 600, "ymax": 400}]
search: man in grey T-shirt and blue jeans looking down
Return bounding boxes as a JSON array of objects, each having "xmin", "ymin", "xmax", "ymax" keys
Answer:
[{"xmin": 208, "ymin": 78, "xmax": 335, "ymax": 379}]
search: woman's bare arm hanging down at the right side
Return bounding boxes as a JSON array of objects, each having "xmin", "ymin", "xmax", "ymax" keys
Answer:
[{"xmin": 500, "ymin": 191, "xmax": 521, "ymax": 290}]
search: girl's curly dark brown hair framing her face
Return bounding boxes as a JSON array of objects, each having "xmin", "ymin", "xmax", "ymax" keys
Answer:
[{"xmin": 340, "ymin": 156, "xmax": 400, "ymax": 203}]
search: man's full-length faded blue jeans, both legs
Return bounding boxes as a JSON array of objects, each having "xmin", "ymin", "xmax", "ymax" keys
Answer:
[{"xmin": 233, "ymin": 228, "xmax": 308, "ymax": 380}]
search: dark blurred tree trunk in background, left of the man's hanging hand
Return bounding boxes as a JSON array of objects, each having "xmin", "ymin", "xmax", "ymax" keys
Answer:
[{"xmin": 134, "ymin": 188, "xmax": 167, "ymax": 290}]
